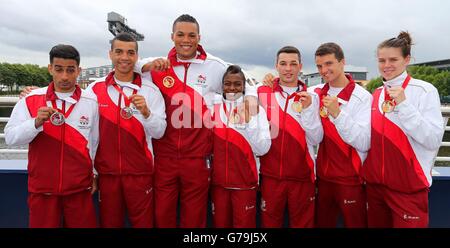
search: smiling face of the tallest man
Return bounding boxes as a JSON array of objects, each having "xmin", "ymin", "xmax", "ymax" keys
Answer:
[{"xmin": 172, "ymin": 22, "xmax": 200, "ymax": 60}]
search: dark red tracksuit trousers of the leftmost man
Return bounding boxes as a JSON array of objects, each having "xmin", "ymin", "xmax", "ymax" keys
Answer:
[{"xmin": 28, "ymin": 190, "xmax": 97, "ymax": 228}]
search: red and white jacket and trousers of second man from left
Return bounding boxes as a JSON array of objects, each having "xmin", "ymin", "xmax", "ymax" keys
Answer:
[{"xmin": 87, "ymin": 72, "xmax": 166, "ymax": 227}]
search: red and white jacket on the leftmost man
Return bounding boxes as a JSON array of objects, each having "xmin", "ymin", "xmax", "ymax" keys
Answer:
[{"xmin": 5, "ymin": 82, "xmax": 98, "ymax": 195}]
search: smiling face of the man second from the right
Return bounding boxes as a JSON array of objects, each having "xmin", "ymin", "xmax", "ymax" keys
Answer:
[{"xmin": 316, "ymin": 54, "xmax": 345, "ymax": 83}]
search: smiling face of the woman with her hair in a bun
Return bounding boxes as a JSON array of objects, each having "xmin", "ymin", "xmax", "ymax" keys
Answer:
[{"xmin": 377, "ymin": 47, "xmax": 411, "ymax": 81}]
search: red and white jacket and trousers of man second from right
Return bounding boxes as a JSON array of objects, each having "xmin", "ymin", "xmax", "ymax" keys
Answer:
[{"xmin": 314, "ymin": 75, "xmax": 372, "ymax": 227}]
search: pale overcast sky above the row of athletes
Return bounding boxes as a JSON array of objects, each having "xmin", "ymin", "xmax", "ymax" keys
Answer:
[{"xmin": 0, "ymin": 0, "xmax": 450, "ymax": 80}]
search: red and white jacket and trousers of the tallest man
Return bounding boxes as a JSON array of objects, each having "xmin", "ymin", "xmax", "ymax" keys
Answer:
[{"xmin": 137, "ymin": 45, "xmax": 256, "ymax": 227}]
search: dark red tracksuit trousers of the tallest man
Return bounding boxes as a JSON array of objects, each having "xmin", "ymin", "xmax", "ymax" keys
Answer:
[{"xmin": 155, "ymin": 156, "xmax": 210, "ymax": 228}]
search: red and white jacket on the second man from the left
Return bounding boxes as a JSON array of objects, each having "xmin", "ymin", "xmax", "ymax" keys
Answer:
[{"xmin": 86, "ymin": 71, "xmax": 166, "ymax": 175}]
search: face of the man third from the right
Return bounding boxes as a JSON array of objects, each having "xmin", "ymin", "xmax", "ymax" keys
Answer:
[{"xmin": 276, "ymin": 53, "xmax": 302, "ymax": 86}]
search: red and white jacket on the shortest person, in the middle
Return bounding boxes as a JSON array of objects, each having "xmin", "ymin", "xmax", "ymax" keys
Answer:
[{"xmin": 211, "ymin": 95, "xmax": 271, "ymax": 189}]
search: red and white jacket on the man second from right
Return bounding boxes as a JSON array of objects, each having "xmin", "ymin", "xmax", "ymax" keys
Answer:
[{"xmin": 314, "ymin": 75, "xmax": 372, "ymax": 185}]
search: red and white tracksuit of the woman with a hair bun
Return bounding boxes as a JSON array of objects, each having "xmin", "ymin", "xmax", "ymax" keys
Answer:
[{"xmin": 363, "ymin": 71, "xmax": 444, "ymax": 227}]
